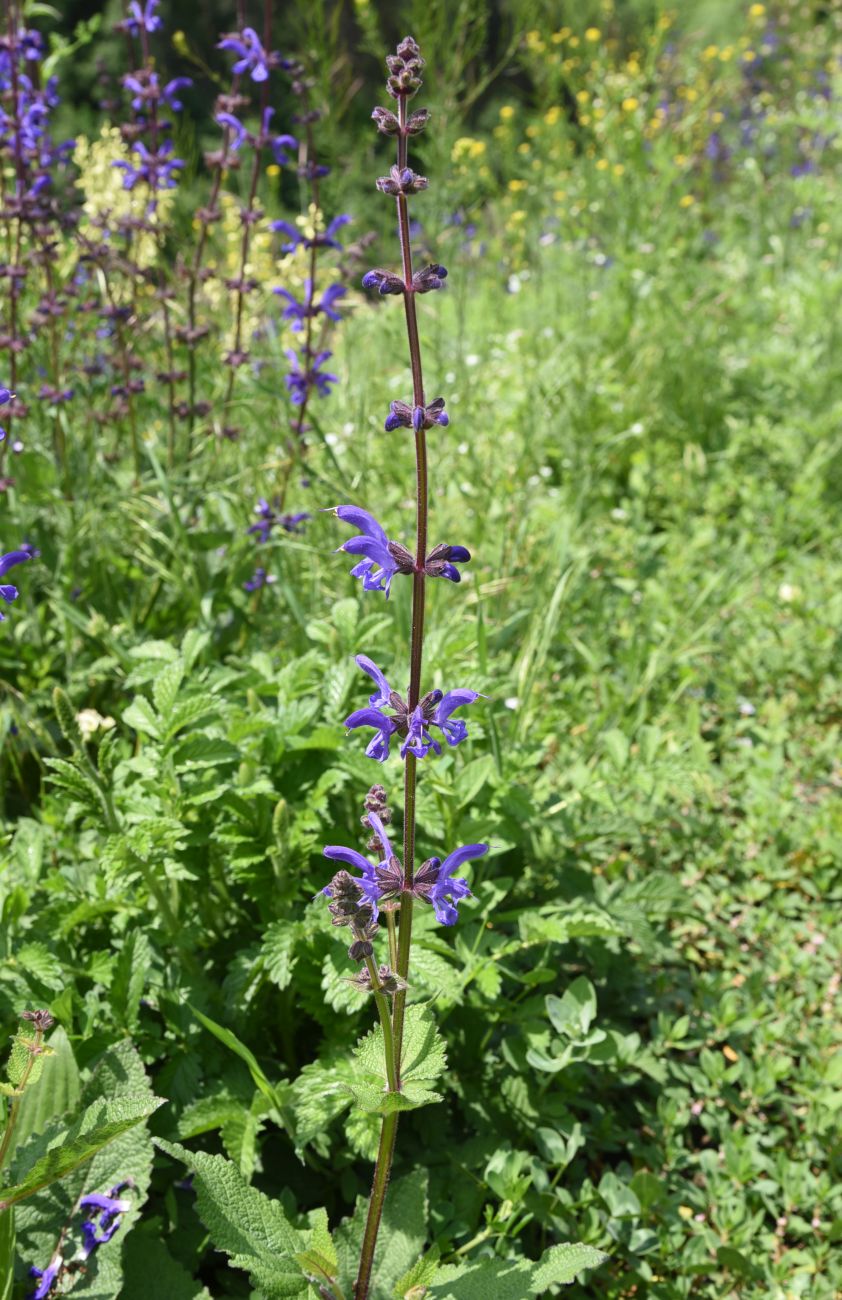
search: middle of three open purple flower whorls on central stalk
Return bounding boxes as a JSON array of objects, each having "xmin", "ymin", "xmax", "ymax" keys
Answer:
[{"xmin": 346, "ymin": 654, "xmax": 479, "ymax": 763}]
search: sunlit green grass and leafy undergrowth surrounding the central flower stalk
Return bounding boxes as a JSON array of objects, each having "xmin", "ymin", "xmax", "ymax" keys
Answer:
[{"xmin": 0, "ymin": 5, "xmax": 842, "ymax": 1300}]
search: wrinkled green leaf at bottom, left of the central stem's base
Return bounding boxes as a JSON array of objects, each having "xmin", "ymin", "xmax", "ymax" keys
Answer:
[{"xmin": 156, "ymin": 1139, "xmax": 308, "ymax": 1300}]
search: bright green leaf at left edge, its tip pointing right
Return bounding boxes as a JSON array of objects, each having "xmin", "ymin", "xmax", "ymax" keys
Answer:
[{"xmin": 0, "ymin": 1093, "xmax": 164, "ymax": 1209}]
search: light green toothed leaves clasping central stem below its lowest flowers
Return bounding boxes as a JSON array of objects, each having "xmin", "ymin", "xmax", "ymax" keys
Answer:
[{"xmin": 347, "ymin": 1006, "xmax": 446, "ymax": 1115}]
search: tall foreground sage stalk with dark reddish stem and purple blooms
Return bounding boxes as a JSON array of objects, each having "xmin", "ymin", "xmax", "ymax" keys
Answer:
[{"xmin": 325, "ymin": 36, "xmax": 487, "ymax": 1300}]
